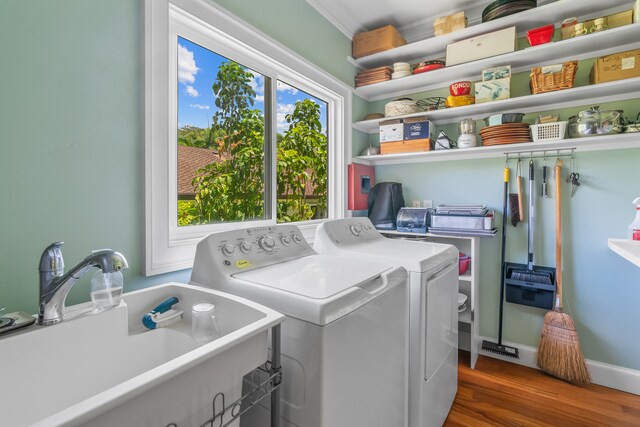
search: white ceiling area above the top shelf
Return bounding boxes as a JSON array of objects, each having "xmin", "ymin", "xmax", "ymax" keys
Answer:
[{"xmin": 306, "ymin": 0, "xmax": 552, "ymax": 43}]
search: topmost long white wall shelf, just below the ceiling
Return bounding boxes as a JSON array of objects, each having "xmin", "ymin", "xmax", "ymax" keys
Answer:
[{"xmin": 354, "ymin": 0, "xmax": 631, "ymax": 68}]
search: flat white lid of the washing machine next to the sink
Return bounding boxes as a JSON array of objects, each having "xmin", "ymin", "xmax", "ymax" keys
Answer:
[{"xmin": 233, "ymin": 254, "xmax": 391, "ymax": 299}]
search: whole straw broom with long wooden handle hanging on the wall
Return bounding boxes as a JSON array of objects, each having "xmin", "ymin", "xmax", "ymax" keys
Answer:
[{"xmin": 537, "ymin": 160, "xmax": 591, "ymax": 384}]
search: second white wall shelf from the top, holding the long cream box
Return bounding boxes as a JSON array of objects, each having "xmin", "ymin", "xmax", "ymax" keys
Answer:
[{"xmin": 356, "ymin": 23, "xmax": 640, "ymax": 101}]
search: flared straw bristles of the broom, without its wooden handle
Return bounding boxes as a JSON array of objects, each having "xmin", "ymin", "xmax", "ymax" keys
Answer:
[{"xmin": 537, "ymin": 309, "xmax": 591, "ymax": 384}]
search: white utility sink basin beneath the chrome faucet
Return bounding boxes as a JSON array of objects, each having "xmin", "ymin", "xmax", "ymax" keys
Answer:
[{"xmin": 0, "ymin": 283, "xmax": 284, "ymax": 427}]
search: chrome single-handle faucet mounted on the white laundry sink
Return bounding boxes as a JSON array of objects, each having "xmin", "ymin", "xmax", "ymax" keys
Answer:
[{"xmin": 38, "ymin": 242, "xmax": 129, "ymax": 325}]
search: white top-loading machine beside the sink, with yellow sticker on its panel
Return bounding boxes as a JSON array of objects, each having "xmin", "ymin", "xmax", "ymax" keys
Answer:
[{"xmin": 190, "ymin": 224, "xmax": 408, "ymax": 427}]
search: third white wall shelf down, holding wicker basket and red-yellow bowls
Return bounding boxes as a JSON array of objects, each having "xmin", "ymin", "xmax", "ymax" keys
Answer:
[{"xmin": 353, "ymin": 77, "xmax": 640, "ymax": 133}]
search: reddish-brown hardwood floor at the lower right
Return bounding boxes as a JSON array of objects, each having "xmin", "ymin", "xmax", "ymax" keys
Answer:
[{"xmin": 444, "ymin": 351, "xmax": 640, "ymax": 427}]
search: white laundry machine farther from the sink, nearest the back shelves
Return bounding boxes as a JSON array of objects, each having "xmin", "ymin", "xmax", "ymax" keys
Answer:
[{"xmin": 314, "ymin": 218, "xmax": 458, "ymax": 427}]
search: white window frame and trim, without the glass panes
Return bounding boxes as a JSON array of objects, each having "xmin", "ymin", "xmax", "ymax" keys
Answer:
[{"xmin": 144, "ymin": 0, "xmax": 351, "ymax": 276}]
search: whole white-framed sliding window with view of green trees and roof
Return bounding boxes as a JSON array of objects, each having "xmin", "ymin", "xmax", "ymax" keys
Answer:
[{"xmin": 145, "ymin": 0, "xmax": 351, "ymax": 275}]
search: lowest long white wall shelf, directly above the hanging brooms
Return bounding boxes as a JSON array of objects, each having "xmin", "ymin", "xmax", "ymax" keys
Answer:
[{"xmin": 353, "ymin": 133, "xmax": 640, "ymax": 166}]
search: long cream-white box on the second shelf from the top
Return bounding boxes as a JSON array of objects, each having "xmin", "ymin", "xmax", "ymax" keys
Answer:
[{"xmin": 446, "ymin": 27, "xmax": 516, "ymax": 67}]
